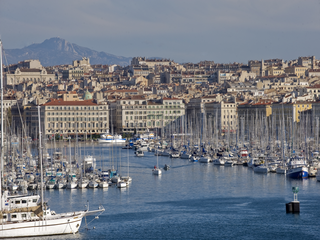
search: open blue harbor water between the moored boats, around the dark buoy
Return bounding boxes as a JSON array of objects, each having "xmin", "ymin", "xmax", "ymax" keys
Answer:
[{"xmin": 27, "ymin": 144, "xmax": 320, "ymax": 239}]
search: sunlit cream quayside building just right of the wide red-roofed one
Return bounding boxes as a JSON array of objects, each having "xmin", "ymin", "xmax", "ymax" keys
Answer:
[{"xmin": 115, "ymin": 96, "xmax": 185, "ymax": 133}]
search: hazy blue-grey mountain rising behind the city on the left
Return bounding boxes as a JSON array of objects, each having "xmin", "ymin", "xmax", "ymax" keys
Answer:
[{"xmin": 5, "ymin": 37, "xmax": 131, "ymax": 66}]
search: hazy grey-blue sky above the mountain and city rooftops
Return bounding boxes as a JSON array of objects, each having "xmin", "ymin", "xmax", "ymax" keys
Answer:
[{"xmin": 0, "ymin": 0, "xmax": 320, "ymax": 63}]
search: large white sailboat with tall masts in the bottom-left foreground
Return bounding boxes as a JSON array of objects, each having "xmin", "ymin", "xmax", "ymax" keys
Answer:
[{"xmin": 0, "ymin": 40, "xmax": 104, "ymax": 238}]
